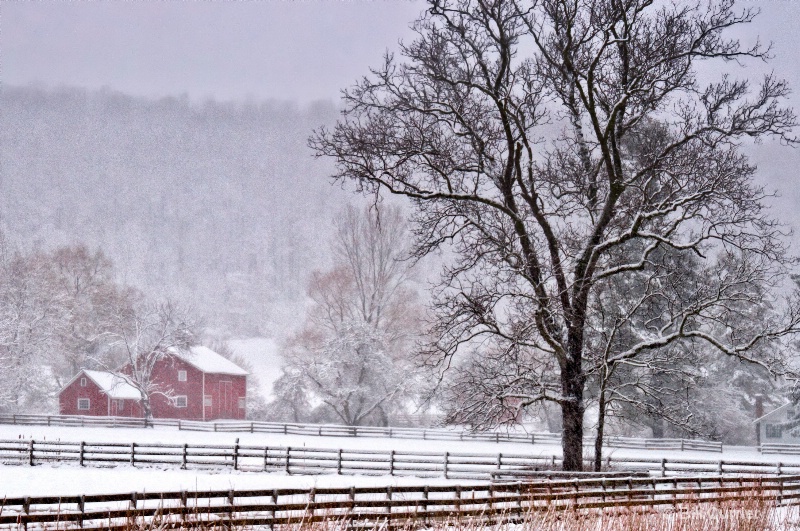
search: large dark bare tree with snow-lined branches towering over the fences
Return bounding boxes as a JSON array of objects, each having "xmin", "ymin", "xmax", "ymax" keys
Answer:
[{"xmin": 310, "ymin": 0, "xmax": 800, "ymax": 470}]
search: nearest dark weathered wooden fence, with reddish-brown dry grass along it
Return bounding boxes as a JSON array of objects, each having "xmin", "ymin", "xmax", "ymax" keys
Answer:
[{"xmin": 0, "ymin": 476, "xmax": 800, "ymax": 530}]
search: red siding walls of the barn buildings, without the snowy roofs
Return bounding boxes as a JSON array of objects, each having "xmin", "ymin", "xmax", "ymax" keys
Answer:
[{"xmin": 59, "ymin": 357, "xmax": 247, "ymax": 420}]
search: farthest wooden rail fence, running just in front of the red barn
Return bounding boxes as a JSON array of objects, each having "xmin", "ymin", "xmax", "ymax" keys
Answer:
[{"xmin": 0, "ymin": 415, "xmax": 722, "ymax": 452}]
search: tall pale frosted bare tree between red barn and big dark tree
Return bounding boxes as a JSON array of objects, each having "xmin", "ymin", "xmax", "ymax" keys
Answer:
[{"xmin": 276, "ymin": 206, "xmax": 420, "ymax": 425}]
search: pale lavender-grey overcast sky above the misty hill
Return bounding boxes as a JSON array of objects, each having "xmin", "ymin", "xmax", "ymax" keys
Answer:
[{"xmin": 0, "ymin": 0, "xmax": 800, "ymax": 242}]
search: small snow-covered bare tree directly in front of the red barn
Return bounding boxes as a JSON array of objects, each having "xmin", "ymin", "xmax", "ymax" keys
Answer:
[{"xmin": 111, "ymin": 301, "xmax": 198, "ymax": 419}]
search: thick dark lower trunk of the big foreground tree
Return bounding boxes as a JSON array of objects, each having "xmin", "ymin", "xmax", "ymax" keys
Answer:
[{"xmin": 561, "ymin": 355, "xmax": 584, "ymax": 472}]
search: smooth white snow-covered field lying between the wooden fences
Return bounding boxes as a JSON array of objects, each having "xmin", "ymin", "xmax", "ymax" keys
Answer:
[{"xmin": 0, "ymin": 425, "xmax": 800, "ymax": 496}]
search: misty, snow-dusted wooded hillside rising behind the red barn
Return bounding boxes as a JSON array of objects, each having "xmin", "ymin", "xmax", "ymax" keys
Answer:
[{"xmin": 0, "ymin": 86, "xmax": 353, "ymax": 336}]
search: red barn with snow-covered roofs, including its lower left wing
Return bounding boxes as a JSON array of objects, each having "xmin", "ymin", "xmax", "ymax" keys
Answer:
[{"xmin": 59, "ymin": 346, "xmax": 247, "ymax": 420}]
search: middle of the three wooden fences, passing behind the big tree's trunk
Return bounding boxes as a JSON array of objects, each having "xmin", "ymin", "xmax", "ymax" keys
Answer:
[{"xmin": 0, "ymin": 439, "xmax": 800, "ymax": 480}]
